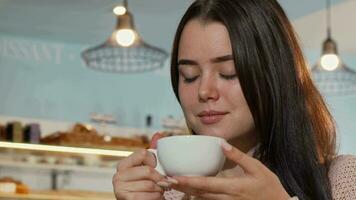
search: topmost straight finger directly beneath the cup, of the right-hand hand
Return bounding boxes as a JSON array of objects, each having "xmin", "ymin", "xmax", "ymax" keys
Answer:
[{"xmin": 172, "ymin": 176, "xmax": 235, "ymax": 194}]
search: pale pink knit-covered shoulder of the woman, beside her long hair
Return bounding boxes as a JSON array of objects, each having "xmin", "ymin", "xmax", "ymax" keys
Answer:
[{"xmin": 329, "ymin": 155, "xmax": 356, "ymax": 200}]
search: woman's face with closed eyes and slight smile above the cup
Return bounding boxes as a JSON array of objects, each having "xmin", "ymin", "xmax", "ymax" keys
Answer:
[{"xmin": 178, "ymin": 20, "xmax": 254, "ymax": 140}]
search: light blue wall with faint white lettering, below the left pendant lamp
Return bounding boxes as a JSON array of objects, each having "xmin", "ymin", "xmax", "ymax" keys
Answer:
[{"xmin": 0, "ymin": 36, "xmax": 182, "ymax": 128}]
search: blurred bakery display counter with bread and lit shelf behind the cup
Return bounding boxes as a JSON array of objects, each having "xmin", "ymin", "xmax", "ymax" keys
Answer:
[{"xmin": 0, "ymin": 116, "xmax": 188, "ymax": 200}]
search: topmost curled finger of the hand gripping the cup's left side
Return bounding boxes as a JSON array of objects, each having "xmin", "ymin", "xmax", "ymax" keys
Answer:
[{"xmin": 117, "ymin": 149, "xmax": 156, "ymax": 171}]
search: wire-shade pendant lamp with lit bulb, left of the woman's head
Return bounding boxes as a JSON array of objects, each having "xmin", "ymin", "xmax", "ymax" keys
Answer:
[{"xmin": 82, "ymin": 0, "xmax": 168, "ymax": 73}]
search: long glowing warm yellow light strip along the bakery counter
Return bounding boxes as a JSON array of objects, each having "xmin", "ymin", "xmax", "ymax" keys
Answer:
[{"xmin": 0, "ymin": 142, "xmax": 132, "ymax": 157}]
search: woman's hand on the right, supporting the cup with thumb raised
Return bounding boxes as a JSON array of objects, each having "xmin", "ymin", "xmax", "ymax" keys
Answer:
[{"xmin": 172, "ymin": 142, "xmax": 290, "ymax": 200}]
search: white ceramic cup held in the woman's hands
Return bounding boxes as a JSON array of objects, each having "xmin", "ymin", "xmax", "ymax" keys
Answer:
[{"xmin": 149, "ymin": 135, "xmax": 225, "ymax": 176}]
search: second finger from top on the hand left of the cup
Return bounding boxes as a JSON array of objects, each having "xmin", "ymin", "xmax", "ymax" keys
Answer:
[{"xmin": 117, "ymin": 165, "xmax": 165, "ymax": 182}]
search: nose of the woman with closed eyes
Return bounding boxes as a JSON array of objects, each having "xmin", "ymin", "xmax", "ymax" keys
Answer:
[{"xmin": 198, "ymin": 75, "xmax": 219, "ymax": 102}]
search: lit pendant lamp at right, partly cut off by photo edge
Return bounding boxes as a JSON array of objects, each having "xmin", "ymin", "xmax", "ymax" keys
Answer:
[{"xmin": 311, "ymin": 0, "xmax": 356, "ymax": 95}]
